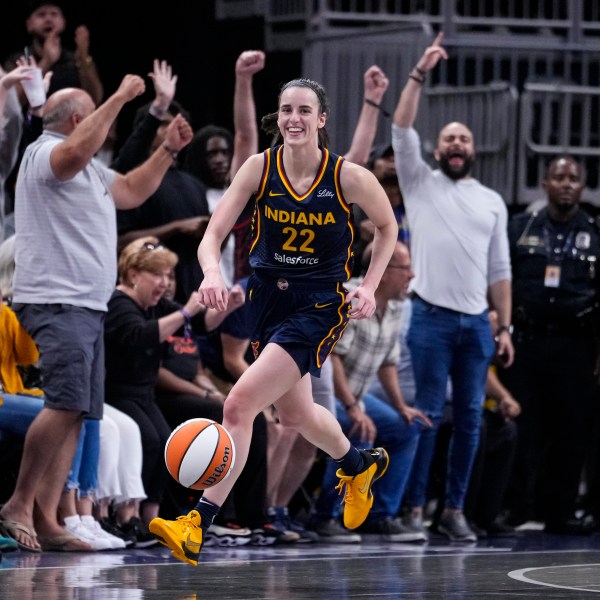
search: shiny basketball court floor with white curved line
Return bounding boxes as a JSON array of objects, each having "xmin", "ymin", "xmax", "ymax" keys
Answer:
[{"xmin": 0, "ymin": 531, "xmax": 600, "ymax": 600}]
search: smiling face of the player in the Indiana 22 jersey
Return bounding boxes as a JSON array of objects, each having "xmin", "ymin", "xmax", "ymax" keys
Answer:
[{"xmin": 277, "ymin": 87, "xmax": 326, "ymax": 144}]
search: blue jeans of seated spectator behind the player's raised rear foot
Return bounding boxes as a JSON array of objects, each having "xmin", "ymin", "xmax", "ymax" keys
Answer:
[{"xmin": 316, "ymin": 394, "xmax": 419, "ymax": 520}]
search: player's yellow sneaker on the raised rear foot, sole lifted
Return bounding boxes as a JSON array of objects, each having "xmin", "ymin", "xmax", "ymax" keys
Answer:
[{"xmin": 335, "ymin": 448, "xmax": 390, "ymax": 529}]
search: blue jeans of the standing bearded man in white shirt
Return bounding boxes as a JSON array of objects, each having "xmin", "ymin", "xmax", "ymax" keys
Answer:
[{"xmin": 407, "ymin": 298, "xmax": 495, "ymax": 509}]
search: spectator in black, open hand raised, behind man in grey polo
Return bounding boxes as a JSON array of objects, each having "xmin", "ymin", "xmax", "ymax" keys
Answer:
[{"xmin": 112, "ymin": 60, "xmax": 209, "ymax": 303}]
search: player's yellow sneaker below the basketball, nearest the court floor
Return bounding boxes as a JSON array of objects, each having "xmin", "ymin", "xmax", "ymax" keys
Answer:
[{"xmin": 148, "ymin": 510, "xmax": 204, "ymax": 566}]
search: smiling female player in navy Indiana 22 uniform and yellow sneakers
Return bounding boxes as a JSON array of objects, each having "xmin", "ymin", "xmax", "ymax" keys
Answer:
[{"xmin": 150, "ymin": 79, "xmax": 398, "ymax": 565}]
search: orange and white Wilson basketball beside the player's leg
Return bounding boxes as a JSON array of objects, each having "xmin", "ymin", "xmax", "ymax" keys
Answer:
[{"xmin": 165, "ymin": 419, "xmax": 235, "ymax": 490}]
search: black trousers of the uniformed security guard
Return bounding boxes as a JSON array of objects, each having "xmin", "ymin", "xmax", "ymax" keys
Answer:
[{"xmin": 498, "ymin": 328, "xmax": 596, "ymax": 523}]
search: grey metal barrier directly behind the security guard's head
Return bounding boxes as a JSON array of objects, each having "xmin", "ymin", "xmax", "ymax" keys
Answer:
[{"xmin": 515, "ymin": 82, "xmax": 600, "ymax": 206}]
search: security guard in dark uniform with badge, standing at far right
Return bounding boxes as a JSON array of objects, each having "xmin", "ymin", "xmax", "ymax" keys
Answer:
[{"xmin": 501, "ymin": 156, "xmax": 600, "ymax": 535}]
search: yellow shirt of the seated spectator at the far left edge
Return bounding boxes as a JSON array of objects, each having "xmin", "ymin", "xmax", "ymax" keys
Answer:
[{"xmin": 0, "ymin": 304, "xmax": 43, "ymax": 404}]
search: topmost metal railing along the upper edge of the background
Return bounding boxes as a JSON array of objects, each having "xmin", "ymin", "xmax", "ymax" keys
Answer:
[{"xmin": 215, "ymin": 0, "xmax": 600, "ymax": 50}]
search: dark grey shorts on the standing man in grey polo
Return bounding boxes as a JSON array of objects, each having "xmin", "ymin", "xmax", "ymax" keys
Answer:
[{"xmin": 12, "ymin": 303, "xmax": 105, "ymax": 419}]
